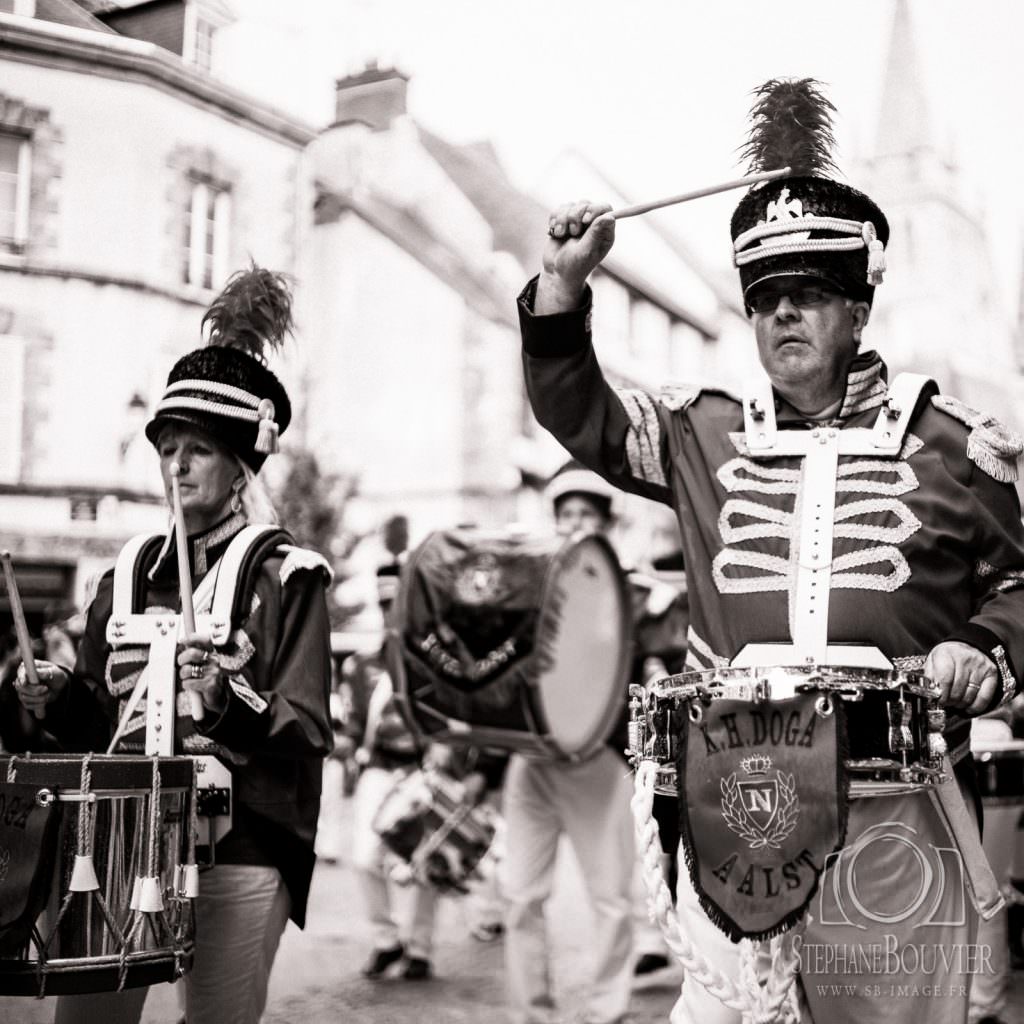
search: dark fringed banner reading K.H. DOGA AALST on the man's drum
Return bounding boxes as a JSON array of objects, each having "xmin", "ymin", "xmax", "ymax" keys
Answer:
[{"xmin": 676, "ymin": 693, "xmax": 848, "ymax": 942}]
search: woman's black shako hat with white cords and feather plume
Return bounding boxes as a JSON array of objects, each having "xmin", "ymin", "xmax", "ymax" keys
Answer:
[{"xmin": 145, "ymin": 264, "xmax": 292, "ymax": 472}]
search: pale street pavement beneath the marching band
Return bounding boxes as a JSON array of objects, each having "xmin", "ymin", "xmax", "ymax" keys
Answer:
[{"xmin": 0, "ymin": 804, "xmax": 1024, "ymax": 1024}]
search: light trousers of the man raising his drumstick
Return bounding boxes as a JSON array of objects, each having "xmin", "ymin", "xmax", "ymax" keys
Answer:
[{"xmin": 671, "ymin": 794, "xmax": 978, "ymax": 1024}]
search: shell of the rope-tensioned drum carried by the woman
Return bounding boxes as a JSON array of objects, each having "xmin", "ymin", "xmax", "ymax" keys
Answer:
[{"xmin": 0, "ymin": 755, "xmax": 195, "ymax": 995}]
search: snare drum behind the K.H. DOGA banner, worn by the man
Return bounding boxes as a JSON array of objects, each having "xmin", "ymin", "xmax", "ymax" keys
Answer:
[{"xmin": 629, "ymin": 666, "xmax": 945, "ymax": 797}]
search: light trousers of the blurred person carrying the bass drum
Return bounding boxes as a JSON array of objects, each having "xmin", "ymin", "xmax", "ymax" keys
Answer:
[{"xmin": 502, "ymin": 748, "xmax": 636, "ymax": 1024}]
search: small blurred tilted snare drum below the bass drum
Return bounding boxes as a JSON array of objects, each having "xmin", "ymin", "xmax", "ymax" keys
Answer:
[{"xmin": 373, "ymin": 769, "xmax": 499, "ymax": 893}]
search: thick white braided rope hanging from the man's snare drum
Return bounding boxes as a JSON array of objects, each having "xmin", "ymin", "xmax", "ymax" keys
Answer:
[{"xmin": 630, "ymin": 761, "xmax": 800, "ymax": 1024}]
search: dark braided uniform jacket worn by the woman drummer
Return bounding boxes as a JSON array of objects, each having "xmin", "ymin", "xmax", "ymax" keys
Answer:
[{"xmin": 47, "ymin": 516, "xmax": 333, "ymax": 927}]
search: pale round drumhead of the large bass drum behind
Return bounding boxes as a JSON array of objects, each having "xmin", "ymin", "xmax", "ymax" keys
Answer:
[{"xmin": 535, "ymin": 535, "xmax": 632, "ymax": 757}]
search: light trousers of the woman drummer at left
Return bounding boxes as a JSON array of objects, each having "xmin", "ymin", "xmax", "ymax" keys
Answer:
[{"xmin": 54, "ymin": 864, "xmax": 291, "ymax": 1024}]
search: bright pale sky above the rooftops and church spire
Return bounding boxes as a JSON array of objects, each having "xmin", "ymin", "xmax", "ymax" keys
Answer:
[{"xmin": 218, "ymin": 0, "xmax": 1024, "ymax": 308}]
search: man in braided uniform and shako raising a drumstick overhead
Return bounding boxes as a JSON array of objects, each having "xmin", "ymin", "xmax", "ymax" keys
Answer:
[{"xmin": 519, "ymin": 80, "xmax": 1024, "ymax": 1024}]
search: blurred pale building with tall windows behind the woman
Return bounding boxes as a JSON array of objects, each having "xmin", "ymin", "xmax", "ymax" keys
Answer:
[{"xmin": 0, "ymin": 0, "xmax": 313, "ymax": 625}]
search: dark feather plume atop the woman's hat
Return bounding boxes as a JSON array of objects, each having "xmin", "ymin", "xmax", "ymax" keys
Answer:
[{"xmin": 202, "ymin": 263, "xmax": 294, "ymax": 362}]
